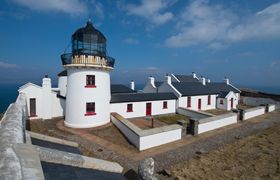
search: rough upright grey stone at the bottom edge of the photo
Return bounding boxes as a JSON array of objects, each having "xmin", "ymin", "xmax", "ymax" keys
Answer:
[{"xmin": 138, "ymin": 158, "xmax": 157, "ymax": 180}]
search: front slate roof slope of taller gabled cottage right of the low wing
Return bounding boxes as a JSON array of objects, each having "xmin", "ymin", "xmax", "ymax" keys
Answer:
[{"xmin": 172, "ymin": 82, "xmax": 220, "ymax": 96}]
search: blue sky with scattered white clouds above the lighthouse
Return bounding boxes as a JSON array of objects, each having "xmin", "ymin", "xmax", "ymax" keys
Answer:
[{"xmin": 0, "ymin": 0, "xmax": 280, "ymax": 87}]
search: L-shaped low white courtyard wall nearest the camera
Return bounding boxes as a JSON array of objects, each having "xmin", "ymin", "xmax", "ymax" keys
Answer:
[{"xmin": 111, "ymin": 113, "xmax": 182, "ymax": 151}]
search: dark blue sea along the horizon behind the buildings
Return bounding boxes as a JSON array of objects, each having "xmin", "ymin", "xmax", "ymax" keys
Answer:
[{"xmin": 0, "ymin": 84, "xmax": 280, "ymax": 113}]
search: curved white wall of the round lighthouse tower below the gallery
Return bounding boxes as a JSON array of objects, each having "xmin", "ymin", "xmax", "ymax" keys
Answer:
[{"xmin": 64, "ymin": 68, "xmax": 111, "ymax": 128}]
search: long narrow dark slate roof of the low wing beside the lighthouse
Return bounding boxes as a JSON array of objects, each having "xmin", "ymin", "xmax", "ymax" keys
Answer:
[{"xmin": 111, "ymin": 93, "xmax": 177, "ymax": 103}]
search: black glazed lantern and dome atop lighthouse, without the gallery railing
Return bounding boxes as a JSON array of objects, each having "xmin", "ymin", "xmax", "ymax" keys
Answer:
[{"xmin": 72, "ymin": 20, "xmax": 106, "ymax": 57}]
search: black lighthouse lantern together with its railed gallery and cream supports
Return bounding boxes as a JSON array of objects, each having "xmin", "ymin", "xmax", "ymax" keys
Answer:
[{"xmin": 61, "ymin": 20, "xmax": 115, "ymax": 69}]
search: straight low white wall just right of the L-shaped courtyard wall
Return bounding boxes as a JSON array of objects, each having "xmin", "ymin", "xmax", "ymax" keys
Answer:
[{"xmin": 198, "ymin": 113, "xmax": 237, "ymax": 134}]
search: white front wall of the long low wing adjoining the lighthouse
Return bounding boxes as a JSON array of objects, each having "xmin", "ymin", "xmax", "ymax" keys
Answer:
[{"xmin": 110, "ymin": 99, "xmax": 176, "ymax": 118}]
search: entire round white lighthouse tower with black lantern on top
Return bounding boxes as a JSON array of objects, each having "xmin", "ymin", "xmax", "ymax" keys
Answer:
[{"xmin": 61, "ymin": 21, "xmax": 115, "ymax": 128}]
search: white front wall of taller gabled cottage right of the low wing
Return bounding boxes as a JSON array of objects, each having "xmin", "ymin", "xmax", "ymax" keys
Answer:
[{"xmin": 179, "ymin": 95, "xmax": 217, "ymax": 111}]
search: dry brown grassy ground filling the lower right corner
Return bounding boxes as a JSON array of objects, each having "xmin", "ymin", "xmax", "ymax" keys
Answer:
[{"xmin": 168, "ymin": 119, "xmax": 280, "ymax": 179}]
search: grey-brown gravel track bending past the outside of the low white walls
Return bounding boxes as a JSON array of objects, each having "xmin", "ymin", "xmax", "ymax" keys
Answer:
[{"xmin": 27, "ymin": 110, "xmax": 280, "ymax": 179}]
